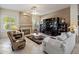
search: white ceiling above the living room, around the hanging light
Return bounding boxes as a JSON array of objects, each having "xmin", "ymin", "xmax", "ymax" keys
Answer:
[{"xmin": 0, "ymin": 4, "xmax": 70, "ymax": 15}]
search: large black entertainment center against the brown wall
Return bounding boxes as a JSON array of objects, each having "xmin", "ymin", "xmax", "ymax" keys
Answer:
[{"xmin": 40, "ymin": 17, "xmax": 67, "ymax": 36}]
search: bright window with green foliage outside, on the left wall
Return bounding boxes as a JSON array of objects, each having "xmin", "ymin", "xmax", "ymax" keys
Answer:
[{"xmin": 1, "ymin": 16, "xmax": 16, "ymax": 31}]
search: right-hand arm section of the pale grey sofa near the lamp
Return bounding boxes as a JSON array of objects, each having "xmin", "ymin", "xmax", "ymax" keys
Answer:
[{"xmin": 60, "ymin": 34, "xmax": 76, "ymax": 53}]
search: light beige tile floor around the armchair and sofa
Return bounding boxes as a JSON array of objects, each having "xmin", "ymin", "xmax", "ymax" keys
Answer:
[{"xmin": 0, "ymin": 38, "xmax": 79, "ymax": 54}]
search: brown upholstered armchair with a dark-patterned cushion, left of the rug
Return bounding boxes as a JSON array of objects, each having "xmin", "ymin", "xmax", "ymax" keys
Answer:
[{"xmin": 7, "ymin": 31, "xmax": 26, "ymax": 51}]
